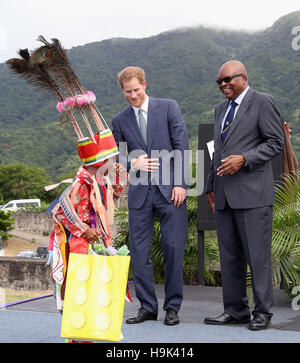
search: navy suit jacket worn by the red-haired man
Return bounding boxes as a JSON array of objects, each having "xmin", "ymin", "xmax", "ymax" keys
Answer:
[{"xmin": 112, "ymin": 97, "xmax": 189, "ymax": 208}]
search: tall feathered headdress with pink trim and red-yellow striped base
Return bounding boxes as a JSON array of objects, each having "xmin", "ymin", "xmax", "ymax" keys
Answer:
[{"xmin": 6, "ymin": 36, "xmax": 118, "ymax": 165}]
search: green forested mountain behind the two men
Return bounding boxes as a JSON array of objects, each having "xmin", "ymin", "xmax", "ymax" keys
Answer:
[{"xmin": 0, "ymin": 11, "xmax": 300, "ymax": 180}]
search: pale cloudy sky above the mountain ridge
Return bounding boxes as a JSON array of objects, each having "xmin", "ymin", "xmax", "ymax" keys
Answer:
[{"xmin": 0, "ymin": 0, "xmax": 300, "ymax": 62}]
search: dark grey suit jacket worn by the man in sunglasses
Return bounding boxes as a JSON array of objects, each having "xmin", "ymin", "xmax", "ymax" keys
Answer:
[{"xmin": 206, "ymin": 88, "xmax": 284, "ymax": 209}]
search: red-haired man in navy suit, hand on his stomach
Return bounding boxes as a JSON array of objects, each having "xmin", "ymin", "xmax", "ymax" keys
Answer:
[{"xmin": 113, "ymin": 67, "xmax": 189, "ymax": 325}]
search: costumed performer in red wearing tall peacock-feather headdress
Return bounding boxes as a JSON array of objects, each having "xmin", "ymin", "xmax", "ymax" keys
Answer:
[{"xmin": 6, "ymin": 36, "xmax": 129, "ymax": 318}]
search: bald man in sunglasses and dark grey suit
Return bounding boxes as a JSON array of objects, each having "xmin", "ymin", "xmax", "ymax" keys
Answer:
[{"xmin": 204, "ymin": 60, "xmax": 284, "ymax": 330}]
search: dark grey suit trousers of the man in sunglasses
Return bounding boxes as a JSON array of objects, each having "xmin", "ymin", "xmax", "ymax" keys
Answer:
[{"xmin": 216, "ymin": 203, "xmax": 273, "ymax": 319}]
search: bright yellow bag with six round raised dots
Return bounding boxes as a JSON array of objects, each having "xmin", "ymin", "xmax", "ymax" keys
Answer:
[{"xmin": 61, "ymin": 253, "xmax": 130, "ymax": 341}]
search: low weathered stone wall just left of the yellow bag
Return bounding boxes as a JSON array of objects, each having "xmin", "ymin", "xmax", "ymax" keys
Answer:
[{"xmin": 0, "ymin": 257, "xmax": 53, "ymax": 291}]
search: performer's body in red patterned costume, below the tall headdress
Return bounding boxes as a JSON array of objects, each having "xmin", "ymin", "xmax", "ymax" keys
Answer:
[{"xmin": 49, "ymin": 148, "xmax": 126, "ymax": 311}]
